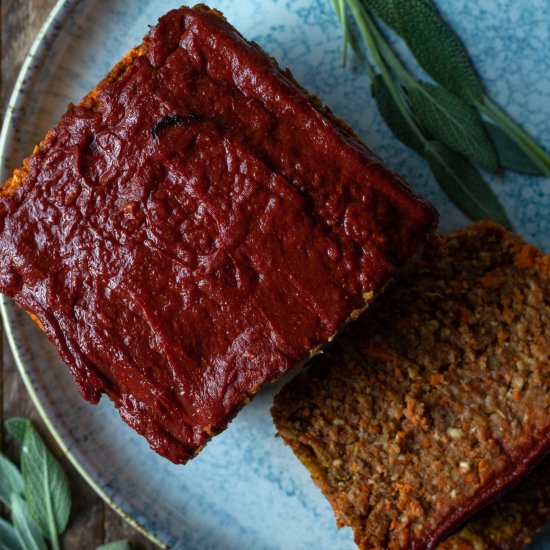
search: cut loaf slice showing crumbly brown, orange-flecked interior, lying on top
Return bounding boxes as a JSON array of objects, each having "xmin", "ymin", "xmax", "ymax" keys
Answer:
[{"xmin": 273, "ymin": 222, "xmax": 550, "ymax": 549}]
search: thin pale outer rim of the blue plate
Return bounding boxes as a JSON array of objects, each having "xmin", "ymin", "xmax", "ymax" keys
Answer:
[{"xmin": 0, "ymin": 0, "xmax": 168, "ymax": 549}]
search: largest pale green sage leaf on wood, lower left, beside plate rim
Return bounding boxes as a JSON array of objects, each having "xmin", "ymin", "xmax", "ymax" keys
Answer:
[{"xmin": 21, "ymin": 421, "xmax": 71, "ymax": 542}]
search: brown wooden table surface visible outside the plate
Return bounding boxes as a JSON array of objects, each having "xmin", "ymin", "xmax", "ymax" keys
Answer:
[{"xmin": 0, "ymin": 0, "xmax": 156, "ymax": 550}]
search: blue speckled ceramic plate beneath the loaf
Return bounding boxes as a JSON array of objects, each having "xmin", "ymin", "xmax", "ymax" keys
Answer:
[{"xmin": 0, "ymin": 0, "xmax": 550, "ymax": 550}]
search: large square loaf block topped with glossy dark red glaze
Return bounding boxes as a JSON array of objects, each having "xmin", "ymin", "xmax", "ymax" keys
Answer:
[{"xmin": 0, "ymin": 6, "xmax": 437, "ymax": 462}]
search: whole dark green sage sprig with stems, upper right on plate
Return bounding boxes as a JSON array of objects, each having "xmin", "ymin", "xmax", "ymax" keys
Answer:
[{"xmin": 333, "ymin": 0, "xmax": 550, "ymax": 229}]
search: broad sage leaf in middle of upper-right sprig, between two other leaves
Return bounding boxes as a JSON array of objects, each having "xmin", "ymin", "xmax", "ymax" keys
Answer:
[{"xmin": 408, "ymin": 82, "xmax": 498, "ymax": 172}]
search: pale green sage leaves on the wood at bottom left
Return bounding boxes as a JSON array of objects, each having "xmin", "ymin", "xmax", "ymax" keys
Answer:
[{"xmin": 0, "ymin": 417, "xmax": 130, "ymax": 550}]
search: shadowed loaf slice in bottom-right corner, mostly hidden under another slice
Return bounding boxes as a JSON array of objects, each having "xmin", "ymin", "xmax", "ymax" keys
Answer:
[{"xmin": 444, "ymin": 457, "xmax": 550, "ymax": 550}]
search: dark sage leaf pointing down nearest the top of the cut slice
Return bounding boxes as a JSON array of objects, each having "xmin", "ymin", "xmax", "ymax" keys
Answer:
[{"xmin": 426, "ymin": 141, "xmax": 514, "ymax": 231}]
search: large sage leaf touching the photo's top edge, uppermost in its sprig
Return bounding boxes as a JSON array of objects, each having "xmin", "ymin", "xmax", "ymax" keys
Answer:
[{"xmin": 392, "ymin": 0, "xmax": 483, "ymax": 105}]
